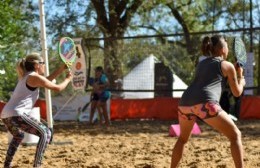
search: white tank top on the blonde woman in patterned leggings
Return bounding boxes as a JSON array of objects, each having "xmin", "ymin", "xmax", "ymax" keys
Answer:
[{"xmin": 1, "ymin": 72, "xmax": 39, "ymax": 118}]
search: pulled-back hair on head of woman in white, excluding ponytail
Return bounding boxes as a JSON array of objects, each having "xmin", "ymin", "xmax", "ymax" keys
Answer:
[{"xmin": 24, "ymin": 53, "xmax": 41, "ymax": 72}]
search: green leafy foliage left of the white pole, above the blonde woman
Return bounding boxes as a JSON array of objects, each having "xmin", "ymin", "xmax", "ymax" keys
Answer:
[{"xmin": 0, "ymin": 0, "xmax": 39, "ymax": 101}]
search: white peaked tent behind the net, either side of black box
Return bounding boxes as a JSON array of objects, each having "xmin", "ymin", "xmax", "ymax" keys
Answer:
[{"xmin": 123, "ymin": 55, "xmax": 187, "ymax": 98}]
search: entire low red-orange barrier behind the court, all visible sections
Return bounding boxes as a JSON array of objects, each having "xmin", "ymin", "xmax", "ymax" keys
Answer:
[{"xmin": 0, "ymin": 96, "xmax": 260, "ymax": 120}]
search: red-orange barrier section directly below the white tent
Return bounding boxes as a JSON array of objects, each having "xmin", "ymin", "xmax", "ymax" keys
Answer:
[{"xmin": 110, "ymin": 97, "xmax": 179, "ymax": 120}]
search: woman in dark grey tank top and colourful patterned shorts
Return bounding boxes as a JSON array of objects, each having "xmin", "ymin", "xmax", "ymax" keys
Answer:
[{"xmin": 171, "ymin": 35, "xmax": 245, "ymax": 168}]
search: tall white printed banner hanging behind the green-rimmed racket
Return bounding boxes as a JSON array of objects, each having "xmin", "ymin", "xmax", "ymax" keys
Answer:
[{"xmin": 71, "ymin": 38, "xmax": 87, "ymax": 90}]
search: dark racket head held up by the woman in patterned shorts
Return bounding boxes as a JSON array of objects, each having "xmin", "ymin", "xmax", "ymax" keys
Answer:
[{"xmin": 233, "ymin": 37, "xmax": 247, "ymax": 67}]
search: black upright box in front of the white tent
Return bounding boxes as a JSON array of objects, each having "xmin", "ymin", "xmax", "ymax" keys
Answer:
[{"xmin": 154, "ymin": 63, "xmax": 173, "ymax": 97}]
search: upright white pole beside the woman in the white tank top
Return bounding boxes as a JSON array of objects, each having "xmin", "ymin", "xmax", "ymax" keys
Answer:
[{"xmin": 39, "ymin": 0, "xmax": 53, "ymax": 128}]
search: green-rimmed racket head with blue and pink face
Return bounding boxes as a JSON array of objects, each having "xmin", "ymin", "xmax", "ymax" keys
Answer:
[{"xmin": 58, "ymin": 37, "xmax": 77, "ymax": 70}]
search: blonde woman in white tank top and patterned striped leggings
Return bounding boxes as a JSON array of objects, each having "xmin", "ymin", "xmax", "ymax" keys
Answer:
[{"xmin": 1, "ymin": 53, "xmax": 72, "ymax": 168}]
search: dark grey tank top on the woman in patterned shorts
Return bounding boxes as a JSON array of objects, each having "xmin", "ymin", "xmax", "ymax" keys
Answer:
[{"xmin": 180, "ymin": 57, "xmax": 227, "ymax": 106}]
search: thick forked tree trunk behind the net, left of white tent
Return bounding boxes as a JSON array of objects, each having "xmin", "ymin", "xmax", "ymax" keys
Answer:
[{"xmin": 91, "ymin": 0, "xmax": 143, "ymax": 89}]
